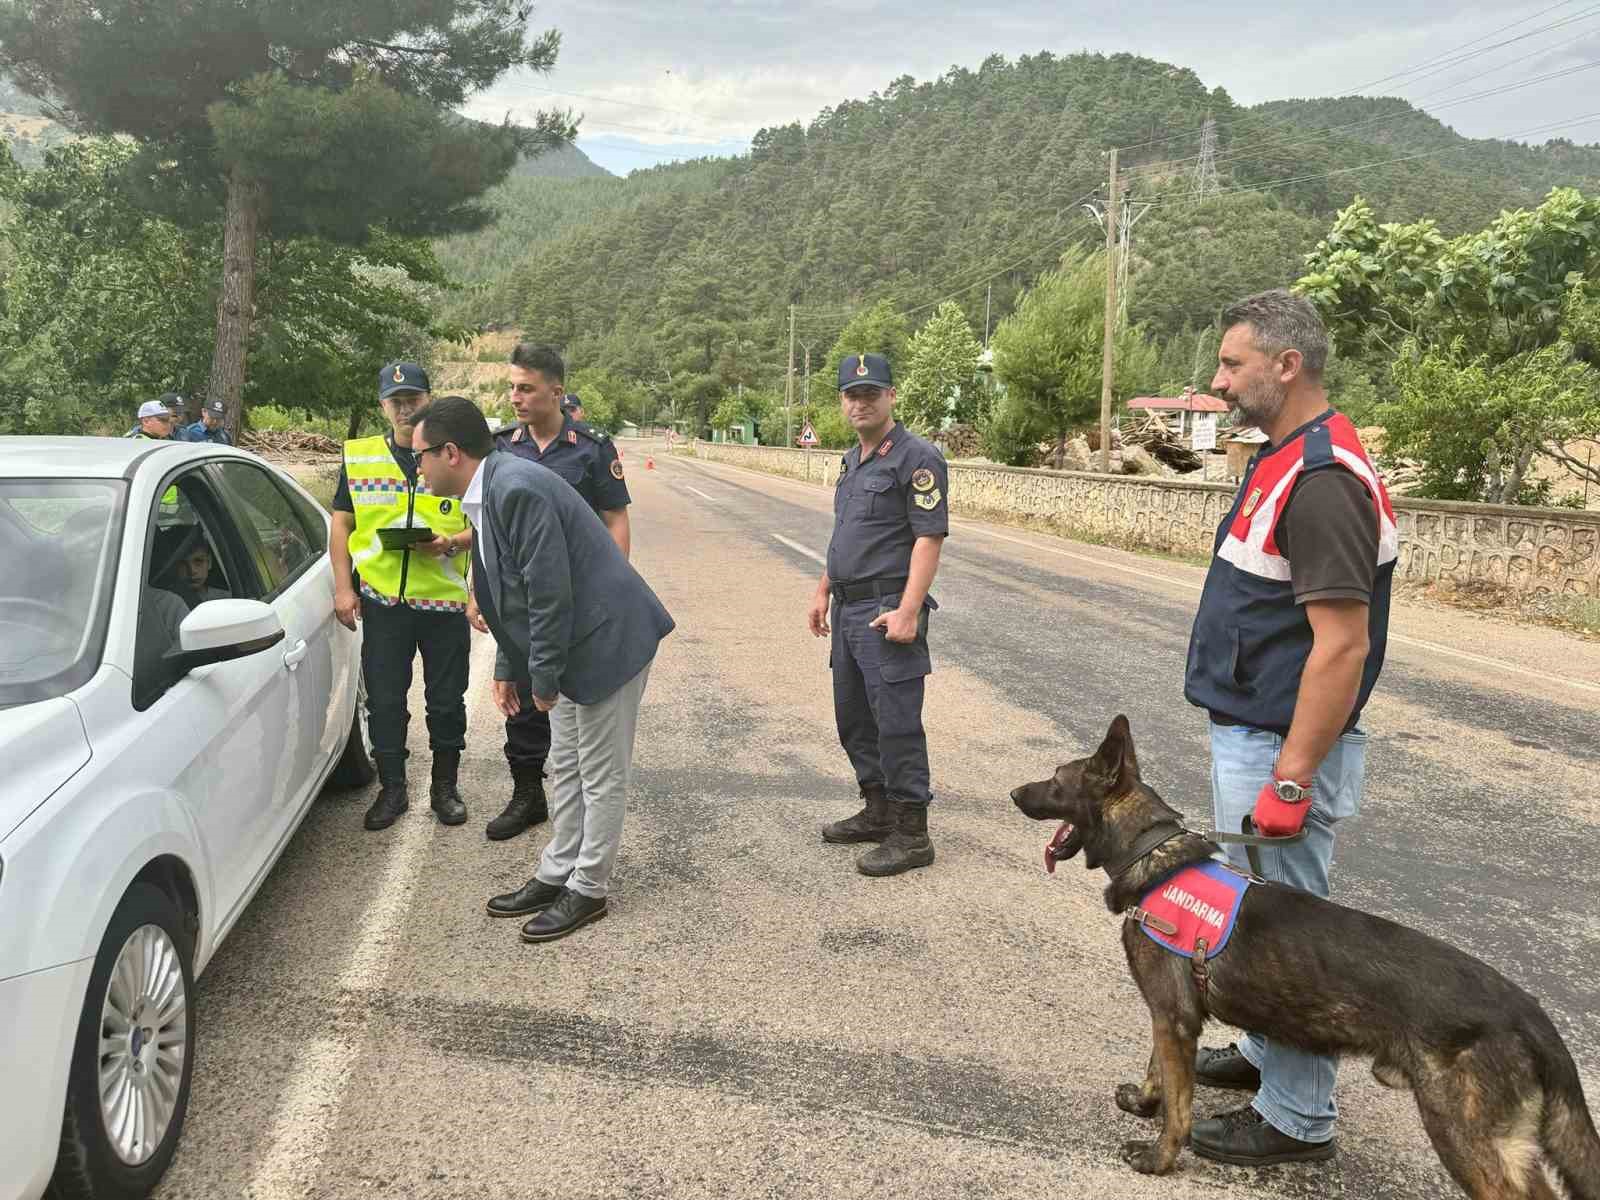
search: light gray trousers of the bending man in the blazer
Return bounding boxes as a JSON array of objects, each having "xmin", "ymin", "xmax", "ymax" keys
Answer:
[{"xmin": 534, "ymin": 662, "xmax": 651, "ymax": 899}]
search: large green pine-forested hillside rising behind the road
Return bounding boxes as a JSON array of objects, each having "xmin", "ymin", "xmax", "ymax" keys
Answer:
[{"xmin": 442, "ymin": 53, "xmax": 1600, "ymax": 438}]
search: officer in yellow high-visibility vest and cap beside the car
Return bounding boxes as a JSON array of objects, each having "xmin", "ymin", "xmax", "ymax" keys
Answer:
[{"xmin": 328, "ymin": 363, "xmax": 472, "ymax": 829}]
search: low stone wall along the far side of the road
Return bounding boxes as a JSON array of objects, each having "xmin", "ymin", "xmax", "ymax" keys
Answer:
[{"xmin": 693, "ymin": 442, "xmax": 1600, "ymax": 595}]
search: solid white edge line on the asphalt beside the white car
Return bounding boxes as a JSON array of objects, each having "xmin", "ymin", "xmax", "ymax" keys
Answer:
[{"xmin": 245, "ymin": 638, "xmax": 494, "ymax": 1200}]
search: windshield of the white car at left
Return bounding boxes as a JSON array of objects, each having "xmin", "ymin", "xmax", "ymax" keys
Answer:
[{"xmin": 0, "ymin": 478, "xmax": 126, "ymax": 707}]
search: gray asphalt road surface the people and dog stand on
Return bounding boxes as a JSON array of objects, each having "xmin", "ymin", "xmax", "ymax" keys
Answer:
[{"xmin": 157, "ymin": 451, "xmax": 1600, "ymax": 1200}]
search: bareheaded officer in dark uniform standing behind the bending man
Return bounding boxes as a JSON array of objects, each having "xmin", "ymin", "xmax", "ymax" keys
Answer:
[{"xmin": 469, "ymin": 342, "xmax": 629, "ymax": 840}]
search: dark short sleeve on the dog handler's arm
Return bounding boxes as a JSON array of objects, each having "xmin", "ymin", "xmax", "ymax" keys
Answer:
[{"xmin": 1275, "ymin": 467, "xmax": 1378, "ymax": 605}]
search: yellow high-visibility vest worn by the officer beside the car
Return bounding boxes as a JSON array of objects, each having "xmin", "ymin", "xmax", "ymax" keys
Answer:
[{"xmin": 344, "ymin": 437, "xmax": 470, "ymax": 613}]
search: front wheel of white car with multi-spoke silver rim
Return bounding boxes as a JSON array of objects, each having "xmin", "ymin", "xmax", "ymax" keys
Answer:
[{"xmin": 53, "ymin": 883, "xmax": 195, "ymax": 1200}]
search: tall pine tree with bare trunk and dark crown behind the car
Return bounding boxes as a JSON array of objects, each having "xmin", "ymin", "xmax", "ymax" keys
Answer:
[{"xmin": 0, "ymin": 0, "xmax": 573, "ymax": 429}]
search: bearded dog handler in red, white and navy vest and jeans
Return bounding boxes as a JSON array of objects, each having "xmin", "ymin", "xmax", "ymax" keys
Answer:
[{"xmin": 1184, "ymin": 290, "xmax": 1400, "ymax": 1166}]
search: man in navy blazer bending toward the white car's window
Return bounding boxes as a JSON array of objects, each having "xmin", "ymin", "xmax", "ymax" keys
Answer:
[{"xmin": 411, "ymin": 395, "xmax": 672, "ymax": 942}]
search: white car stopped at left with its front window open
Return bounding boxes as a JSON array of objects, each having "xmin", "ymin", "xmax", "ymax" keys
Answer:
[{"xmin": 0, "ymin": 437, "xmax": 371, "ymax": 1200}]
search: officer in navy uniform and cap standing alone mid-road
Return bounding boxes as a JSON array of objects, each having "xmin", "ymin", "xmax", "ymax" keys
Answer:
[{"xmin": 808, "ymin": 354, "xmax": 950, "ymax": 875}]
